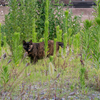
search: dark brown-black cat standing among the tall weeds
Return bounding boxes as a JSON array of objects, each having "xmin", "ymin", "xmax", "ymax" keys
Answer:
[{"xmin": 23, "ymin": 40, "xmax": 63, "ymax": 63}]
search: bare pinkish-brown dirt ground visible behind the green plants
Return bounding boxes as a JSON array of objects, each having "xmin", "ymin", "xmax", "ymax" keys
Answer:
[{"xmin": 0, "ymin": 6, "xmax": 94, "ymax": 24}]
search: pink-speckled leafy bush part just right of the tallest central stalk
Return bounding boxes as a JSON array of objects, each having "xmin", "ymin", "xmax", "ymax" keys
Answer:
[{"xmin": 49, "ymin": 0, "xmax": 64, "ymax": 39}]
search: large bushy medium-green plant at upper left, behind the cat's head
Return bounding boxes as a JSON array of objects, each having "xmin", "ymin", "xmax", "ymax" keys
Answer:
[{"xmin": 5, "ymin": 0, "xmax": 37, "ymax": 51}]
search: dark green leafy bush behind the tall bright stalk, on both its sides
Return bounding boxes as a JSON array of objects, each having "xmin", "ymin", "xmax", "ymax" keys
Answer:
[{"xmin": 36, "ymin": 0, "xmax": 63, "ymax": 39}]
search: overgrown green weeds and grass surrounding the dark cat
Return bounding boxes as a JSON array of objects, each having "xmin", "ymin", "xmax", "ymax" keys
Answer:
[{"xmin": 0, "ymin": 0, "xmax": 100, "ymax": 100}]
